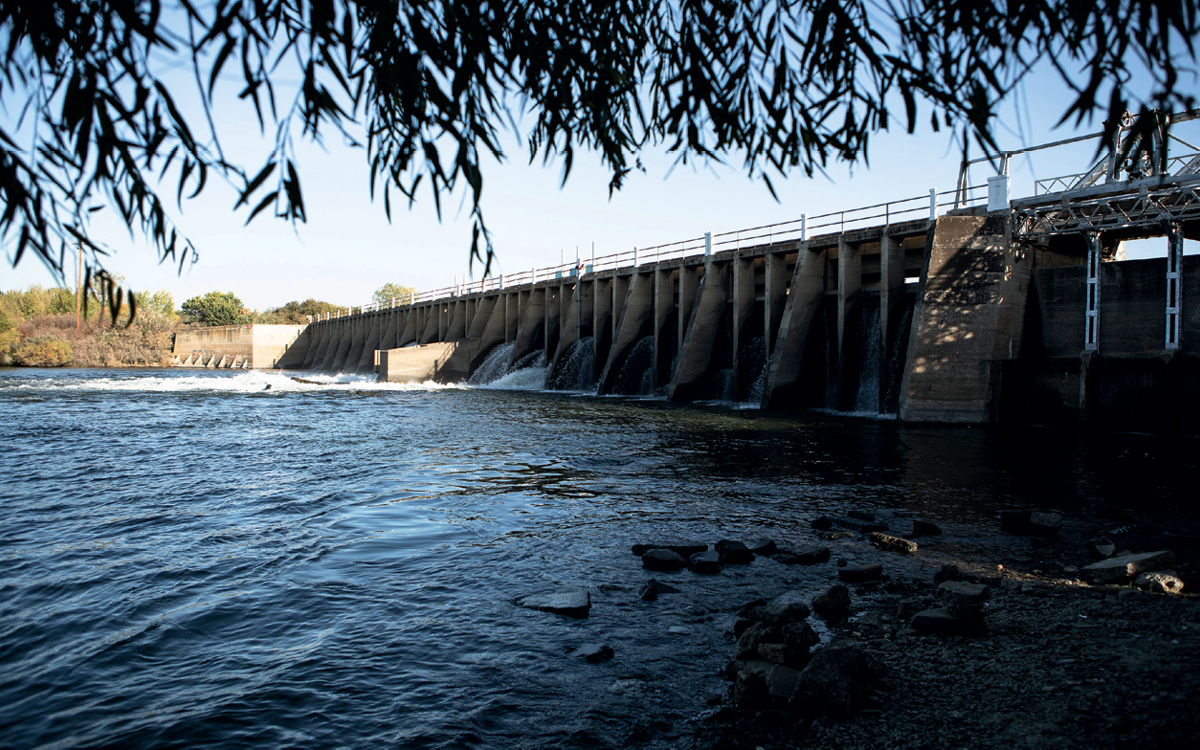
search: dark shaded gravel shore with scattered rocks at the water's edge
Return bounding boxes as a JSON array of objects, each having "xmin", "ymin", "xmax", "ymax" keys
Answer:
[{"xmin": 516, "ymin": 510, "xmax": 1200, "ymax": 749}]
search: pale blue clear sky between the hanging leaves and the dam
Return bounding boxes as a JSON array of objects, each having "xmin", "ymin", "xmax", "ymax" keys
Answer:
[{"xmin": 0, "ymin": 54, "xmax": 1200, "ymax": 310}]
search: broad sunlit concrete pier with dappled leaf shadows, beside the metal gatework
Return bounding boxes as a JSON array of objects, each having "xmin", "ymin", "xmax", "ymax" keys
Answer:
[{"xmin": 899, "ymin": 216, "xmax": 1032, "ymax": 424}]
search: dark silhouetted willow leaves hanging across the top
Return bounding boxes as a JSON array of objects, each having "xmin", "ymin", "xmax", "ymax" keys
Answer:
[{"xmin": 0, "ymin": 0, "xmax": 1200, "ymax": 292}]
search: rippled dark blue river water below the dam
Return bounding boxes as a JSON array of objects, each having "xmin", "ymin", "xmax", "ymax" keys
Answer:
[{"xmin": 0, "ymin": 370, "xmax": 1196, "ymax": 748}]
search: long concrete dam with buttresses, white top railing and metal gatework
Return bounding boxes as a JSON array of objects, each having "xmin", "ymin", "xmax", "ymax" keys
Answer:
[{"xmin": 265, "ymin": 127, "xmax": 1200, "ymax": 434}]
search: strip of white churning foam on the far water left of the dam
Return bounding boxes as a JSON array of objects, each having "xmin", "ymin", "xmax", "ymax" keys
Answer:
[{"xmin": 37, "ymin": 370, "xmax": 462, "ymax": 394}]
